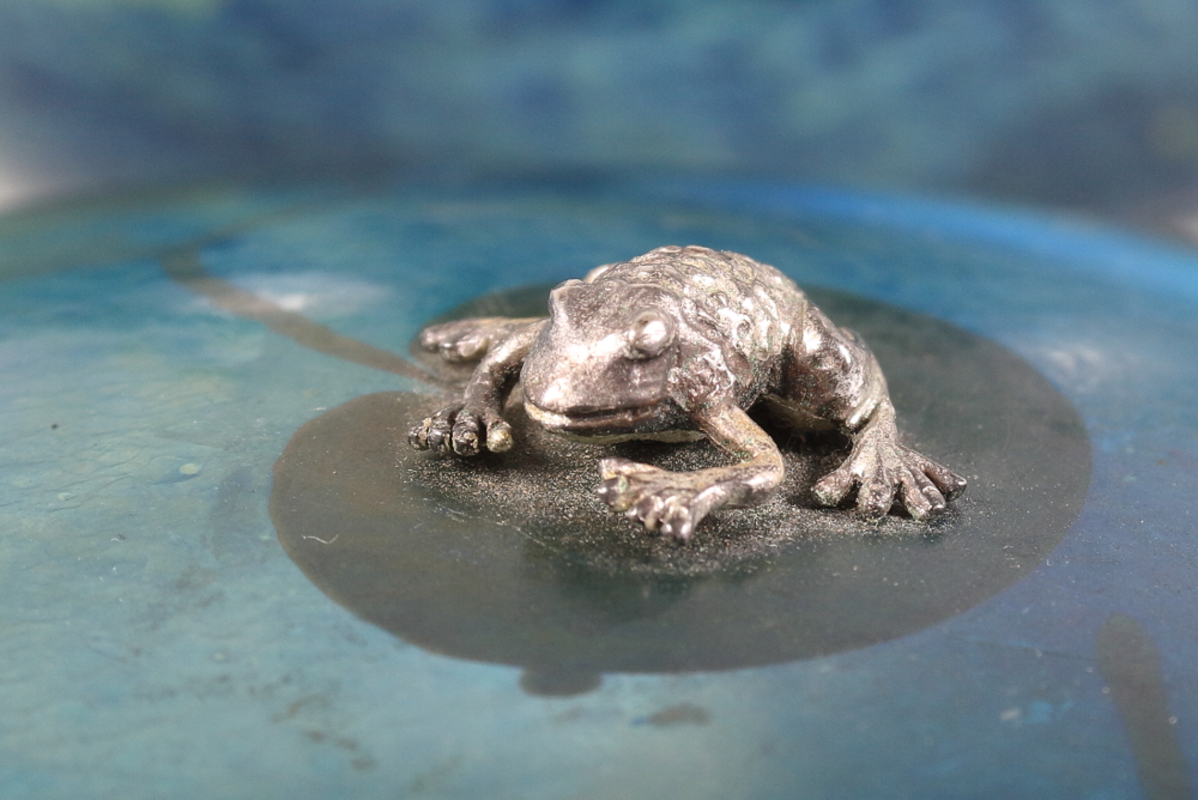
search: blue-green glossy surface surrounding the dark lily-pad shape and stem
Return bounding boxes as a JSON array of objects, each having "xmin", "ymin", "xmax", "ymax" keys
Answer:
[{"xmin": 0, "ymin": 182, "xmax": 1198, "ymax": 800}]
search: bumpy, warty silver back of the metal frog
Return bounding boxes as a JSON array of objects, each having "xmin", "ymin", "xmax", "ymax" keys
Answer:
[{"xmin": 586, "ymin": 246, "xmax": 806, "ymax": 363}]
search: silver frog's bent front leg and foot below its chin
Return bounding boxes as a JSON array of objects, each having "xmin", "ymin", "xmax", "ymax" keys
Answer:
[{"xmin": 598, "ymin": 400, "xmax": 783, "ymax": 541}]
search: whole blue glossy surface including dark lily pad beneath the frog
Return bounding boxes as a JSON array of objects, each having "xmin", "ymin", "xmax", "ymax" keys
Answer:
[{"xmin": 0, "ymin": 181, "xmax": 1198, "ymax": 799}]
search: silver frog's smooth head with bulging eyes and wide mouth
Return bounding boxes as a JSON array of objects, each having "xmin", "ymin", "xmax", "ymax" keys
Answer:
[{"xmin": 520, "ymin": 280, "xmax": 680, "ymax": 438}]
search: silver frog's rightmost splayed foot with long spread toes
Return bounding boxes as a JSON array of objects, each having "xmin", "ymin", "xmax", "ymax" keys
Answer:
[{"xmin": 815, "ymin": 436, "xmax": 966, "ymax": 521}]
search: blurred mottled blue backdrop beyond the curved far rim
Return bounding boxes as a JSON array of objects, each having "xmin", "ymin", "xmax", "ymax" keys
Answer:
[{"xmin": 0, "ymin": 0, "xmax": 1198, "ymax": 237}]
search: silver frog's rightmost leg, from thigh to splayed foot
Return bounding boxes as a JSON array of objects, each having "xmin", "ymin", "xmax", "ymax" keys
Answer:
[{"xmin": 787, "ymin": 305, "xmax": 966, "ymax": 520}]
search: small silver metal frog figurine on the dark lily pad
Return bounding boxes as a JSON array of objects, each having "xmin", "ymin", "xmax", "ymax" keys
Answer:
[{"xmin": 407, "ymin": 244, "xmax": 967, "ymax": 541}]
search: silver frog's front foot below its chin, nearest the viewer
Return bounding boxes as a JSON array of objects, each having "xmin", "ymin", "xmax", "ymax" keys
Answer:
[{"xmin": 597, "ymin": 459, "xmax": 726, "ymax": 541}]
